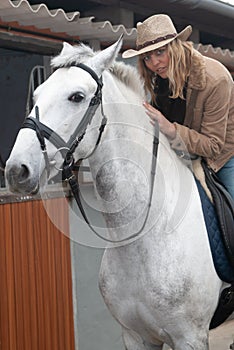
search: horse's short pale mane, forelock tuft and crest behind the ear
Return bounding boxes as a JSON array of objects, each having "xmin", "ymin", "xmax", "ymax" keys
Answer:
[{"xmin": 51, "ymin": 43, "xmax": 145, "ymax": 98}]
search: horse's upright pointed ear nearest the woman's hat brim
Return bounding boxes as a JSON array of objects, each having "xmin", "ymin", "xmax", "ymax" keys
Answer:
[{"xmin": 89, "ymin": 35, "xmax": 123, "ymax": 76}]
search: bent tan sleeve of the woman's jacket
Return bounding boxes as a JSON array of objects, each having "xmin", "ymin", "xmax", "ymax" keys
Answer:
[{"xmin": 171, "ymin": 77, "xmax": 231, "ymax": 159}]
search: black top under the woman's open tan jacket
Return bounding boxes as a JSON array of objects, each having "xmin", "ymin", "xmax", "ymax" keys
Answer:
[{"xmin": 154, "ymin": 76, "xmax": 186, "ymax": 124}]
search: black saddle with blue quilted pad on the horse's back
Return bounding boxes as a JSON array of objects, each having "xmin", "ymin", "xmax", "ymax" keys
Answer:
[{"xmin": 193, "ymin": 159, "xmax": 234, "ymax": 329}]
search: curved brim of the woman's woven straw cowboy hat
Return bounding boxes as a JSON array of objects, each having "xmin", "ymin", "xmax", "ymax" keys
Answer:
[{"xmin": 122, "ymin": 26, "xmax": 192, "ymax": 58}]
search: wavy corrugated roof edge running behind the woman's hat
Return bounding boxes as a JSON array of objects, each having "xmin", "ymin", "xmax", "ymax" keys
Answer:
[{"xmin": 0, "ymin": 0, "xmax": 234, "ymax": 70}]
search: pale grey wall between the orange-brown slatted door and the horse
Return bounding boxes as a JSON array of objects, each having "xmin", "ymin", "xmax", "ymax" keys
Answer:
[{"xmin": 70, "ymin": 185, "xmax": 124, "ymax": 350}]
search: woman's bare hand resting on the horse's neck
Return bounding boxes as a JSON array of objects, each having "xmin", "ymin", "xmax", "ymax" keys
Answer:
[{"xmin": 143, "ymin": 102, "xmax": 176, "ymax": 140}]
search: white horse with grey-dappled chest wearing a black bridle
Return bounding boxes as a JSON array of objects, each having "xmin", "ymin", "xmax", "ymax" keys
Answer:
[{"xmin": 6, "ymin": 40, "xmax": 228, "ymax": 350}]
